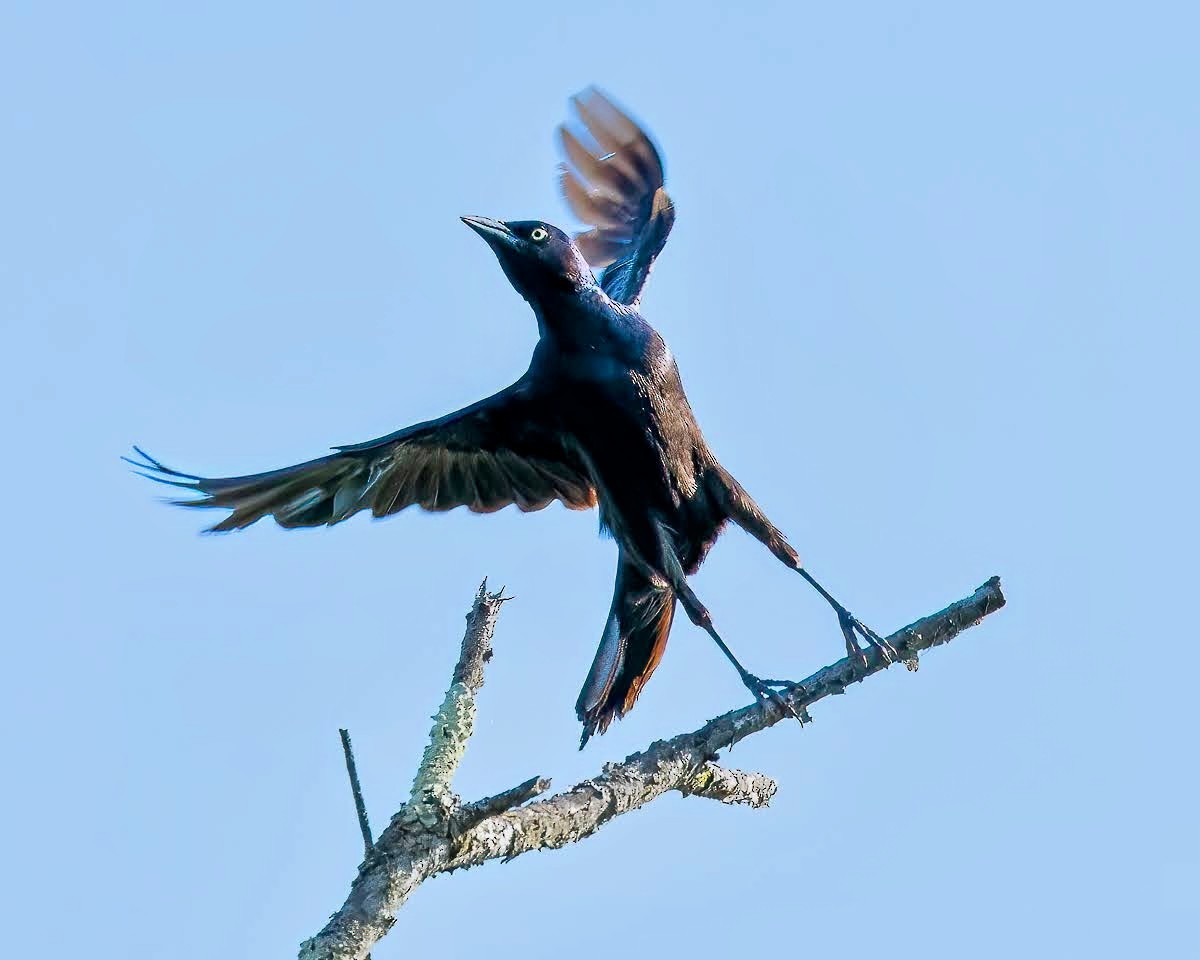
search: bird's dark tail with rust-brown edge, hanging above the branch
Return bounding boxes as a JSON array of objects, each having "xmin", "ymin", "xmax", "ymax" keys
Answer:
[{"xmin": 575, "ymin": 558, "xmax": 676, "ymax": 750}]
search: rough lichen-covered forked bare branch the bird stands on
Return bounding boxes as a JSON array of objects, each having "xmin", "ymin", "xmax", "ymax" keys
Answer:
[{"xmin": 300, "ymin": 577, "xmax": 1004, "ymax": 960}]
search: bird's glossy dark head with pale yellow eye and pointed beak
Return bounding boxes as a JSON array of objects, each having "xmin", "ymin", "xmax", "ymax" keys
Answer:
[{"xmin": 462, "ymin": 217, "xmax": 595, "ymax": 302}]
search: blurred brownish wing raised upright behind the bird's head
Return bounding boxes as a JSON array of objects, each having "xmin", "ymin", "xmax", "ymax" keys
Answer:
[{"xmin": 558, "ymin": 88, "xmax": 674, "ymax": 304}]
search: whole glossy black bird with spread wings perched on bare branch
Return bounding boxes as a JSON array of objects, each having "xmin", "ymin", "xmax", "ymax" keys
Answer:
[{"xmin": 131, "ymin": 89, "xmax": 895, "ymax": 746}]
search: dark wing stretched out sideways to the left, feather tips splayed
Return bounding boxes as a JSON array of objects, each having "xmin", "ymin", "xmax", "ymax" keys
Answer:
[{"xmin": 126, "ymin": 379, "xmax": 596, "ymax": 532}]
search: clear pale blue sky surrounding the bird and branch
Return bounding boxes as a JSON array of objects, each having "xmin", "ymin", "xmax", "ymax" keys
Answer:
[{"xmin": 0, "ymin": 2, "xmax": 1200, "ymax": 960}]
